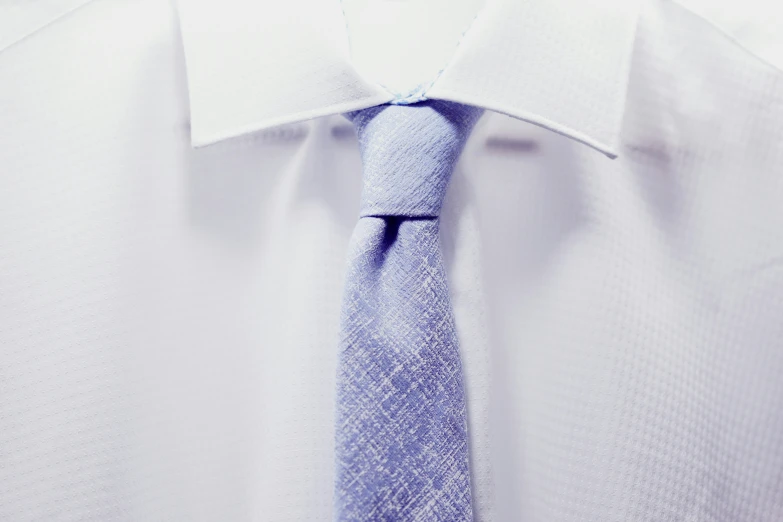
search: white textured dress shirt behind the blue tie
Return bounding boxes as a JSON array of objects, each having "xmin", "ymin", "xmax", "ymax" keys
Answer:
[{"xmin": 0, "ymin": 0, "xmax": 783, "ymax": 522}]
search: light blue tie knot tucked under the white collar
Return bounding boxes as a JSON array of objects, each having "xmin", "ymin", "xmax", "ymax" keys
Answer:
[{"xmin": 346, "ymin": 100, "xmax": 482, "ymax": 217}]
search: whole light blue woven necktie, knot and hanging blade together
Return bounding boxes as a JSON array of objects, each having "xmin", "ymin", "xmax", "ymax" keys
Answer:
[{"xmin": 335, "ymin": 101, "xmax": 482, "ymax": 522}]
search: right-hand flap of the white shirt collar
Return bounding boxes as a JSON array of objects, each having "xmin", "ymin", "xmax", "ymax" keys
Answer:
[{"xmin": 428, "ymin": 0, "xmax": 640, "ymax": 157}]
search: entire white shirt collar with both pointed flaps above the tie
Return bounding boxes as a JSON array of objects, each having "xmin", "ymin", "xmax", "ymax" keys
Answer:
[{"xmin": 178, "ymin": 0, "xmax": 639, "ymax": 157}]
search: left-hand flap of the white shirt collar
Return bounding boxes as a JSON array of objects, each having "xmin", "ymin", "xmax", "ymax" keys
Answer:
[{"xmin": 178, "ymin": 0, "xmax": 392, "ymax": 146}]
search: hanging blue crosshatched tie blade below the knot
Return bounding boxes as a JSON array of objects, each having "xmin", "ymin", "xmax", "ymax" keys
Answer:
[{"xmin": 336, "ymin": 218, "xmax": 472, "ymax": 521}]
